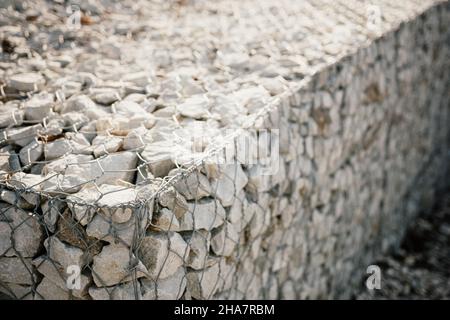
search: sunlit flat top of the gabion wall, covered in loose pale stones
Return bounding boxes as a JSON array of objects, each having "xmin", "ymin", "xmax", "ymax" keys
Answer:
[{"xmin": 0, "ymin": 0, "xmax": 442, "ymax": 206}]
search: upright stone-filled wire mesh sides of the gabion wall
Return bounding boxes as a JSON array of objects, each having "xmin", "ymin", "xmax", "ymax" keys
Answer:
[{"xmin": 0, "ymin": 3, "xmax": 450, "ymax": 299}]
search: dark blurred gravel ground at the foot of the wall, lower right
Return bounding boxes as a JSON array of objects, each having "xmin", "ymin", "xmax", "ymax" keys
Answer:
[{"xmin": 356, "ymin": 190, "xmax": 450, "ymax": 299}]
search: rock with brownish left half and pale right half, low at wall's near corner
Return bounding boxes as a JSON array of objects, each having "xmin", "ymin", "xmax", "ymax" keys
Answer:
[{"xmin": 138, "ymin": 232, "xmax": 189, "ymax": 281}]
